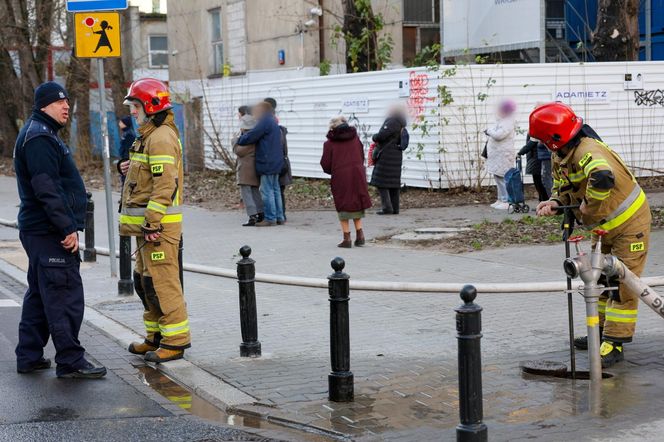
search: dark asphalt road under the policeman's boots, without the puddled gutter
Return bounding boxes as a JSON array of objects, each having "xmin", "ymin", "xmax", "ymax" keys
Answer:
[{"xmin": 0, "ymin": 274, "xmax": 282, "ymax": 442}]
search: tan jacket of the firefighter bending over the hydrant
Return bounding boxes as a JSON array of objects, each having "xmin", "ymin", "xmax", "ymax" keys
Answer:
[{"xmin": 551, "ymin": 137, "xmax": 650, "ymax": 231}]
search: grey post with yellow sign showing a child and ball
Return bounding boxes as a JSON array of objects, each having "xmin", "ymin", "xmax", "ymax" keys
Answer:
[{"xmin": 67, "ymin": 7, "xmax": 122, "ymax": 277}]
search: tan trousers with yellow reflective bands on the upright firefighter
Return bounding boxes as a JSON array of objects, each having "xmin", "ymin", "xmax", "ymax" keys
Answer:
[{"xmin": 136, "ymin": 237, "xmax": 191, "ymax": 349}]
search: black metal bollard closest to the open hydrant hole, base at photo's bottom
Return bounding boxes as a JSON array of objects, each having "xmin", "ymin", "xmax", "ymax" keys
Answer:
[{"xmin": 454, "ymin": 285, "xmax": 487, "ymax": 442}]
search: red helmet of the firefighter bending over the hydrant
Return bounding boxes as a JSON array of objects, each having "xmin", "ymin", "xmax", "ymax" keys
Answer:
[{"xmin": 528, "ymin": 102, "xmax": 583, "ymax": 152}]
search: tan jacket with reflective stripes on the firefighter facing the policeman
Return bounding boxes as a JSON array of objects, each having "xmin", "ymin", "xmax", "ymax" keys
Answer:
[{"xmin": 120, "ymin": 110, "xmax": 184, "ymax": 243}]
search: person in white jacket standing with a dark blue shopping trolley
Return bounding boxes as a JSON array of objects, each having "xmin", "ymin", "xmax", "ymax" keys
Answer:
[{"xmin": 484, "ymin": 100, "xmax": 516, "ymax": 210}]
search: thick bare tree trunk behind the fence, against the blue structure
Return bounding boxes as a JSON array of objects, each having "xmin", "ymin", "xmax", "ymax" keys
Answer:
[{"xmin": 592, "ymin": 0, "xmax": 639, "ymax": 61}]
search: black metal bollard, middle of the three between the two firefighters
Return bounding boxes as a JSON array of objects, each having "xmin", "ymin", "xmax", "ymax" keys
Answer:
[{"xmin": 327, "ymin": 258, "xmax": 354, "ymax": 402}]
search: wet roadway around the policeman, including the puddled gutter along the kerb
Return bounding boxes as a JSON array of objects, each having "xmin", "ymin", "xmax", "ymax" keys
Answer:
[{"xmin": 0, "ymin": 272, "xmax": 329, "ymax": 442}]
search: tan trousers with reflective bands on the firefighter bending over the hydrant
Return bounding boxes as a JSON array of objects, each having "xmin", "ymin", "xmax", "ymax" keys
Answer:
[{"xmin": 599, "ymin": 209, "xmax": 651, "ymax": 342}]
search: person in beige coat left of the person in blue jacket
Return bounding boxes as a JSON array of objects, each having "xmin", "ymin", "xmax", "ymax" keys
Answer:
[{"xmin": 233, "ymin": 114, "xmax": 265, "ymax": 227}]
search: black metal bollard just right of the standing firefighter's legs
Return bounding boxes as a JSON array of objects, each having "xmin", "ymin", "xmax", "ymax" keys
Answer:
[{"xmin": 237, "ymin": 246, "xmax": 261, "ymax": 358}]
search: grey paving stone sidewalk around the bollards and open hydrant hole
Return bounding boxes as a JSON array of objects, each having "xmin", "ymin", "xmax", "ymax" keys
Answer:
[{"xmin": 0, "ymin": 177, "xmax": 664, "ymax": 441}]
